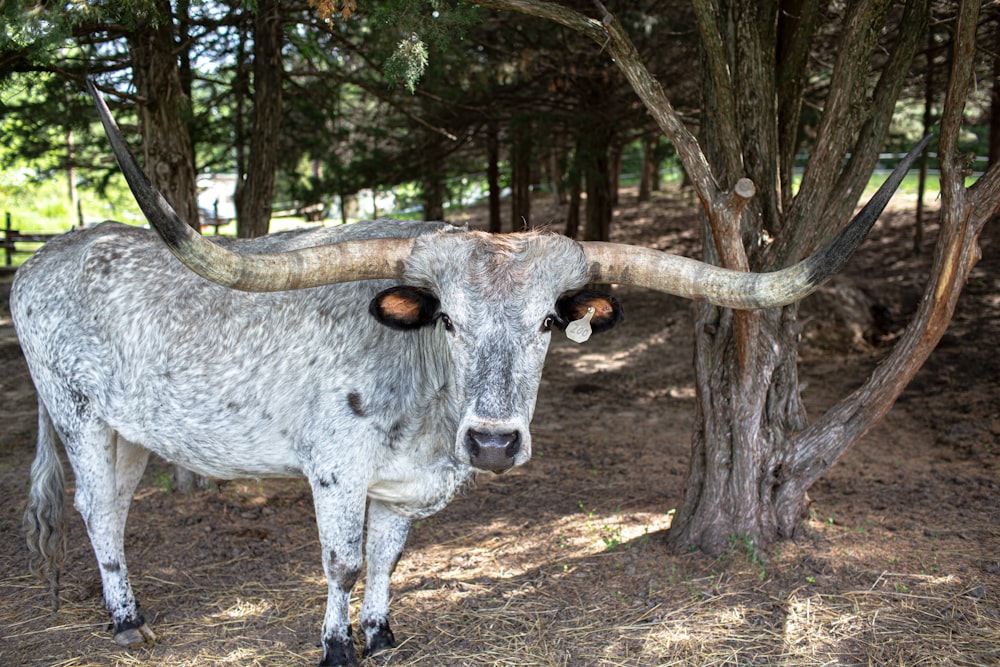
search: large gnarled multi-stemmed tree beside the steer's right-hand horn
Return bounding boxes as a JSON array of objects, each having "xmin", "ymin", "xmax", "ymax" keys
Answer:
[{"xmin": 476, "ymin": 0, "xmax": 1000, "ymax": 553}]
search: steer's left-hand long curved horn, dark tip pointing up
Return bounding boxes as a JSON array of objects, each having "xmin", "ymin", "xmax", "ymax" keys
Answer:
[{"xmin": 87, "ymin": 79, "xmax": 414, "ymax": 292}]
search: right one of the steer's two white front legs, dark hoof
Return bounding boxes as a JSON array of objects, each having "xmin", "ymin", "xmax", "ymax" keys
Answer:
[{"xmin": 361, "ymin": 500, "xmax": 410, "ymax": 656}]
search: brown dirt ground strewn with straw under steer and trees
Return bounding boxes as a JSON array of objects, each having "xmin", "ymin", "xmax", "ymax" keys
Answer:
[{"xmin": 0, "ymin": 193, "xmax": 1000, "ymax": 667}]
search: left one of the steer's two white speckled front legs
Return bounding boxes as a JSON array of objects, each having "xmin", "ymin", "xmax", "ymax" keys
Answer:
[{"xmin": 310, "ymin": 475, "xmax": 365, "ymax": 667}]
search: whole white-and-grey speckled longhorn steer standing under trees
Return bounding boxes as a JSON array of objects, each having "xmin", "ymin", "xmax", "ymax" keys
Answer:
[{"xmin": 11, "ymin": 85, "xmax": 928, "ymax": 665}]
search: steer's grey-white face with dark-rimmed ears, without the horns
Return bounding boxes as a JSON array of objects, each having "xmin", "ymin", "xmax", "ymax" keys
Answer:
[{"xmin": 370, "ymin": 234, "xmax": 622, "ymax": 473}]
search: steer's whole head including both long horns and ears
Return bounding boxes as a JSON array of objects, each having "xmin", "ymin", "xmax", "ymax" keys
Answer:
[{"xmin": 88, "ymin": 81, "xmax": 928, "ymax": 471}]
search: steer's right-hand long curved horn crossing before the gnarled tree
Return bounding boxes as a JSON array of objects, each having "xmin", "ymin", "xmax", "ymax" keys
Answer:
[{"xmin": 582, "ymin": 136, "xmax": 931, "ymax": 310}]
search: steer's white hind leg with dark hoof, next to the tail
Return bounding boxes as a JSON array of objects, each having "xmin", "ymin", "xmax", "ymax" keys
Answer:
[{"xmin": 64, "ymin": 424, "xmax": 156, "ymax": 646}]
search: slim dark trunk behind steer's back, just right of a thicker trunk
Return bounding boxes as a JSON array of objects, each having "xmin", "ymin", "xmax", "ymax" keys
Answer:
[{"xmin": 235, "ymin": 0, "xmax": 284, "ymax": 238}]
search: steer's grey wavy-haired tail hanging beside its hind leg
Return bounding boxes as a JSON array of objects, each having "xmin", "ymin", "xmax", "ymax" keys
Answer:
[{"xmin": 24, "ymin": 398, "xmax": 66, "ymax": 612}]
